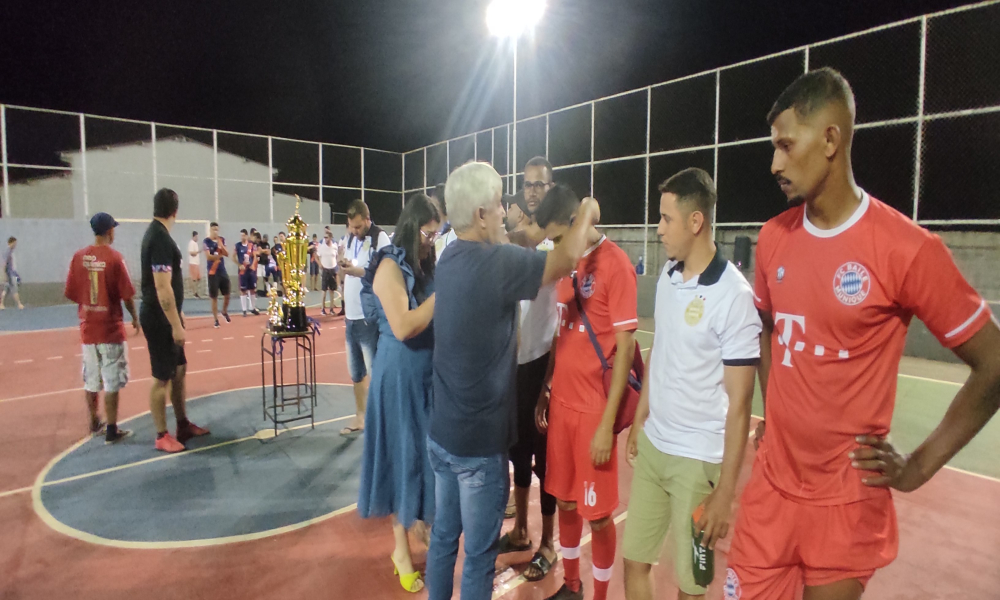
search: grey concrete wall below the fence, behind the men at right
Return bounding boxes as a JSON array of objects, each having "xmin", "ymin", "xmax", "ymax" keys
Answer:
[{"xmin": 604, "ymin": 227, "xmax": 1000, "ymax": 362}]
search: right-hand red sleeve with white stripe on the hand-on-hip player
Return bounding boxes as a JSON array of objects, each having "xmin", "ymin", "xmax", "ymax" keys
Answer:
[{"xmin": 899, "ymin": 235, "xmax": 993, "ymax": 348}]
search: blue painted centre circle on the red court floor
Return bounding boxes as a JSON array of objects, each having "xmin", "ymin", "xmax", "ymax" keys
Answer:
[{"xmin": 40, "ymin": 384, "xmax": 364, "ymax": 545}]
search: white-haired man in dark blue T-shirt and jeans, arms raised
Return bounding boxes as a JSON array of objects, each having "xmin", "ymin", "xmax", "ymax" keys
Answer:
[{"xmin": 427, "ymin": 163, "xmax": 600, "ymax": 600}]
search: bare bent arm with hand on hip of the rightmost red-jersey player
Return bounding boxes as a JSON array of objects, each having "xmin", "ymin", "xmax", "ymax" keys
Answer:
[{"xmin": 850, "ymin": 321, "xmax": 1000, "ymax": 492}]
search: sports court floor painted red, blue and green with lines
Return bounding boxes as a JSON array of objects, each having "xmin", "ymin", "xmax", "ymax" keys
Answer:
[{"xmin": 0, "ymin": 299, "xmax": 1000, "ymax": 600}]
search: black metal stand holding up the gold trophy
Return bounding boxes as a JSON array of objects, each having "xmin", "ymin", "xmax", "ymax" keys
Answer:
[{"xmin": 260, "ymin": 331, "xmax": 316, "ymax": 435}]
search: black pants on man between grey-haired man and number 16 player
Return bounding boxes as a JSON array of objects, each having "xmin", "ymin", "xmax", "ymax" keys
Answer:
[{"xmin": 510, "ymin": 354, "xmax": 556, "ymax": 516}]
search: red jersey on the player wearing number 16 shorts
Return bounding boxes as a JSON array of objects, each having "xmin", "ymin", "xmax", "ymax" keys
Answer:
[{"xmin": 552, "ymin": 237, "xmax": 639, "ymax": 413}]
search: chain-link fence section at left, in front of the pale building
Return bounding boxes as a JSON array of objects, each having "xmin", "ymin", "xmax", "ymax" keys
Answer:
[{"xmin": 0, "ymin": 105, "xmax": 402, "ymax": 225}]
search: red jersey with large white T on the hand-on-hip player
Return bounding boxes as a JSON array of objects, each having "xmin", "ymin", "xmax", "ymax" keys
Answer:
[{"xmin": 754, "ymin": 193, "xmax": 992, "ymax": 505}]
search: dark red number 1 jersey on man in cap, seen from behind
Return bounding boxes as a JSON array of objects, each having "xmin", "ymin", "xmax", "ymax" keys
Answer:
[{"xmin": 65, "ymin": 246, "xmax": 135, "ymax": 344}]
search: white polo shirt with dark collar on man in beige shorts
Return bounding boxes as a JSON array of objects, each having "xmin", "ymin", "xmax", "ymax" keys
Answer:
[{"xmin": 643, "ymin": 252, "xmax": 761, "ymax": 464}]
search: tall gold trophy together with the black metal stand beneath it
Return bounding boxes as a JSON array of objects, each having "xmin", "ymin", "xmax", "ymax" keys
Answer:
[{"xmin": 260, "ymin": 196, "xmax": 316, "ymax": 435}]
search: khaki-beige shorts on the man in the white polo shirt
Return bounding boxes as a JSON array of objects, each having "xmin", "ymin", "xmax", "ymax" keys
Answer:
[{"xmin": 622, "ymin": 431, "xmax": 722, "ymax": 596}]
